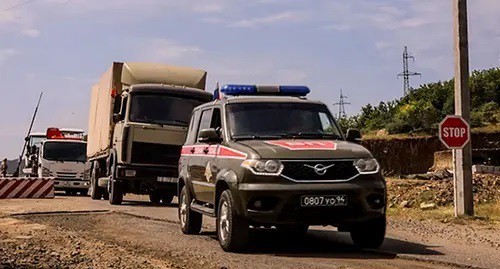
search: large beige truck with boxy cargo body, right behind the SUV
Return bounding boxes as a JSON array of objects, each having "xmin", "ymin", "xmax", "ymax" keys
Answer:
[{"xmin": 87, "ymin": 63, "xmax": 212, "ymax": 205}]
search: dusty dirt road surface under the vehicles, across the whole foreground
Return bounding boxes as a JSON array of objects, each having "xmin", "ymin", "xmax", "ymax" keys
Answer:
[{"xmin": 0, "ymin": 197, "xmax": 500, "ymax": 268}]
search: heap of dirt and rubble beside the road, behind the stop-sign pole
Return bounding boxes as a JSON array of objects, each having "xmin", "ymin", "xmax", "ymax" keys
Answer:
[{"xmin": 387, "ymin": 174, "xmax": 500, "ymax": 207}]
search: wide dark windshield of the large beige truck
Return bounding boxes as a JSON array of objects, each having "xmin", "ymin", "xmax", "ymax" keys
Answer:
[{"xmin": 130, "ymin": 93, "xmax": 207, "ymax": 126}]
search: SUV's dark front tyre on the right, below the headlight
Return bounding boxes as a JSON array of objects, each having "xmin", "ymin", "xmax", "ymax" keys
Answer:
[{"xmin": 350, "ymin": 216, "xmax": 386, "ymax": 249}]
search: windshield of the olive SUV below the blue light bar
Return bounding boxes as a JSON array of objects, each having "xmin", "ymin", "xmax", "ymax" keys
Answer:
[{"xmin": 227, "ymin": 102, "xmax": 342, "ymax": 139}]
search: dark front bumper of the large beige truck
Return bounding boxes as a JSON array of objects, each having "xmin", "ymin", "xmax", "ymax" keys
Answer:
[{"xmin": 116, "ymin": 165, "xmax": 178, "ymax": 194}]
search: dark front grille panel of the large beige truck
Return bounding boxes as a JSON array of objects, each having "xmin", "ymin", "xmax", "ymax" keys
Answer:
[{"xmin": 131, "ymin": 142, "xmax": 182, "ymax": 166}]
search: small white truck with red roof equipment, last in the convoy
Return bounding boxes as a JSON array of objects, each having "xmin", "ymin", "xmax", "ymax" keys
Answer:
[{"xmin": 37, "ymin": 128, "xmax": 90, "ymax": 196}]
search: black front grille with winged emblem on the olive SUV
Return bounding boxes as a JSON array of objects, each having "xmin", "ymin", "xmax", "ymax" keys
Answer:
[{"xmin": 281, "ymin": 160, "xmax": 359, "ymax": 182}]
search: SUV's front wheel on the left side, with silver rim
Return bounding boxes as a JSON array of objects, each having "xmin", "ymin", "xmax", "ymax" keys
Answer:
[{"xmin": 216, "ymin": 190, "xmax": 249, "ymax": 252}]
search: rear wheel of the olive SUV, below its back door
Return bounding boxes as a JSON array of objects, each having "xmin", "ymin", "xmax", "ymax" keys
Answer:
[{"xmin": 179, "ymin": 186, "xmax": 203, "ymax": 234}]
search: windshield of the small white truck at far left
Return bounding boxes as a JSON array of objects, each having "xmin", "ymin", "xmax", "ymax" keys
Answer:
[{"xmin": 43, "ymin": 142, "xmax": 87, "ymax": 162}]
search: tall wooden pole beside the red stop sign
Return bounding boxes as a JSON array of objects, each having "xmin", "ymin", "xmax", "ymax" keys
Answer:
[{"xmin": 452, "ymin": 0, "xmax": 474, "ymax": 217}]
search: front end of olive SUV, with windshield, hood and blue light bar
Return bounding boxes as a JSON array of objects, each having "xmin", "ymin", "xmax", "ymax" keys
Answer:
[{"xmin": 180, "ymin": 85, "xmax": 386, "ymax": 250}]
